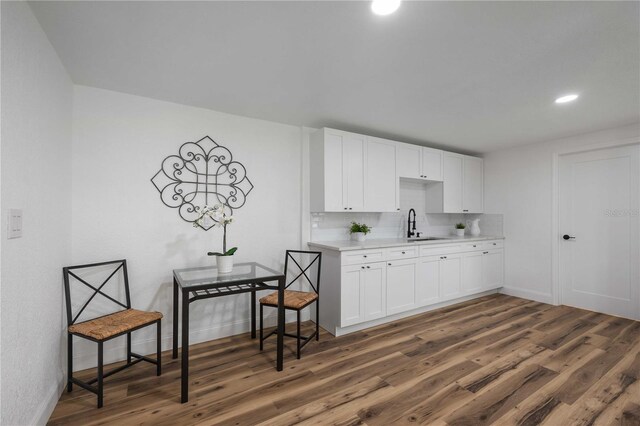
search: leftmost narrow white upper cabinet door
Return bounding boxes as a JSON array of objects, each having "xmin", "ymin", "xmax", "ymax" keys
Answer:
[{"xmin": 324, "ymin": 132, "xmax": 346, "ymax": 212}]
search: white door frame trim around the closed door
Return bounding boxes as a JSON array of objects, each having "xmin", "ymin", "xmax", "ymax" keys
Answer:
[{"xmin": 551, "ymin": 137, "xmax": 640, "ymax": 315}]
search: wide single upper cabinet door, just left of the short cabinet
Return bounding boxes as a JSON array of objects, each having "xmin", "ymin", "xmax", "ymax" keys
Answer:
[{"xmin": 364, "ymin": 137, "xmax": 397, "ymax": 212}]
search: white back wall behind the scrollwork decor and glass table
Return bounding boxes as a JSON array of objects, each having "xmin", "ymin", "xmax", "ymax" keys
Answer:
[{"xmin": 72, "ymin": 86, "xmax": 302, "ymax": 369}]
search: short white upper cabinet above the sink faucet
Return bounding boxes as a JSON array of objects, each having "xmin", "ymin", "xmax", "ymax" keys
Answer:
[{"xmin": 396, "ymin": 142, "xmax": 443, "ymax": 181}]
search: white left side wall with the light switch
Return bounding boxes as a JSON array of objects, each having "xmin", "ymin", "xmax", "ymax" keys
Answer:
[{"xmin": 0, "ymin": 2, "xmax": 72, "ymax": 425}]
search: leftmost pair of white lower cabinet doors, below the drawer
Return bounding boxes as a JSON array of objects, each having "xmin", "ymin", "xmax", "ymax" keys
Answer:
[{"xmin": 340, "ymin": 262, "xmax": 387, "ymax": 327}]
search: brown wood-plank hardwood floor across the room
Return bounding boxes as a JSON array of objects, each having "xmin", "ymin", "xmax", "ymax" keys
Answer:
[{"xmin": 50, "ymin": 295, "xmax": 640, "ymax": 426}]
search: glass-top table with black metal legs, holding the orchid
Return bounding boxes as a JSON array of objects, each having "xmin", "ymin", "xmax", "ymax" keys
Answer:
[{"xmin": 172, "ymin": 262, "xmax": 285, "ymax": 403}]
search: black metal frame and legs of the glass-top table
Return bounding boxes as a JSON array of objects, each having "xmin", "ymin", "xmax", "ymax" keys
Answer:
[{"xmin": 172, "ymin": 262, "xmax": 285, "ymax": 404}]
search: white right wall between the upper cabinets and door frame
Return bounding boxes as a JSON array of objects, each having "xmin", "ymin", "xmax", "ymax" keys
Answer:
[{"xmin": 484, "ymin": 124, "xmax": 640, "ymax": 303}]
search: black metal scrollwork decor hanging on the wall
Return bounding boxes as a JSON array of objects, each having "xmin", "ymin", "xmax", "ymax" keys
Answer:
[{"xmin": 151, "ymin": 136, "xmax": 253, "ymax": 231}]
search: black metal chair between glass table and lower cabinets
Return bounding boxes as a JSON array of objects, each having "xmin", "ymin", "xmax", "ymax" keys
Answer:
[{"xmin": 260, "ymin": 250, "xmax": 322, "ymax": 359}]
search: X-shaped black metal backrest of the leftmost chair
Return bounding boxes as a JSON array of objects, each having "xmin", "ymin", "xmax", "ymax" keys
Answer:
[{"xmin": 62, "ymin": 260, "xmax": 131, "ymax": 325}]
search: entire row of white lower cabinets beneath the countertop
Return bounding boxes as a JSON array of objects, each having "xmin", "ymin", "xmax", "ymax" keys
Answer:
[{"xmin": 332, "ymin": 240, "xmax": 504, "ymax": 332}]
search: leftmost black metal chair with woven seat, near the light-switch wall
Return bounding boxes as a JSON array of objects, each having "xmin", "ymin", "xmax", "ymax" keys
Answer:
[{"xmin": 62, "ymin": 260, "xmax": 162, "ymax": 408}]
